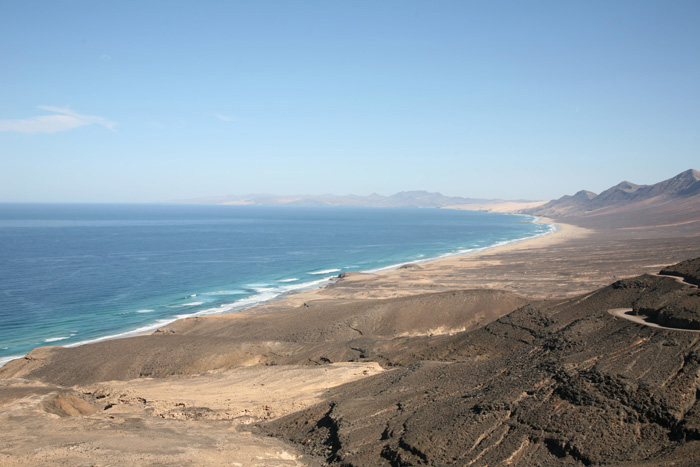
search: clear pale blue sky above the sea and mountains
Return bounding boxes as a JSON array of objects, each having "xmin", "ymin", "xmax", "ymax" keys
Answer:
[{"xmin": 0, "ymin": 0, "xmax": 700, "ymax": 202}]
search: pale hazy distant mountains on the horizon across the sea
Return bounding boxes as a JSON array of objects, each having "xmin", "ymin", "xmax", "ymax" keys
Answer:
[{"xmin": 178, "ymin": 191, "xmax": 502, "ymax": 208}]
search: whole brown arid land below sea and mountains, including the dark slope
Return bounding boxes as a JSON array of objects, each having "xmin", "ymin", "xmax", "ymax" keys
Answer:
[{"xmin": 0, "ymin": 172, "xmax": 700, "ymax": 466}]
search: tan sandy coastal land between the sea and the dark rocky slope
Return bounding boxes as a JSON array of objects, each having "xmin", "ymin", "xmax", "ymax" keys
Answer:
[{"xmin": 0, "ymin": 213, "xmax": 700, "ymax": 465}]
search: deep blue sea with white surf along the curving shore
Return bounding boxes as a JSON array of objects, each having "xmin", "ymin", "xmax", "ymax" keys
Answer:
[{"xmin": 0, "ymin": 204, "xmax": 552, "ymax": 365}]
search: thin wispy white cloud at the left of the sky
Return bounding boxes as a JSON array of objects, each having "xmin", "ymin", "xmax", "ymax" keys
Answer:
[{"xmin": 0, "ymin": 105, "xmax": 116, "ymax": 133}]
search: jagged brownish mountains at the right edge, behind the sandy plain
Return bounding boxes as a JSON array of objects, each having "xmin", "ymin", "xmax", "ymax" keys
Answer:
[{"xmin": 527, "ymin": 169, "xmax": 700, "ymax": 231}]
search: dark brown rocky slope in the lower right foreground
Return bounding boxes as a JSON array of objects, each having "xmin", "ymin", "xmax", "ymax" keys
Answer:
[{"xmin": 261, "ymin": 262, "xmax": 700, "ymax": 466}]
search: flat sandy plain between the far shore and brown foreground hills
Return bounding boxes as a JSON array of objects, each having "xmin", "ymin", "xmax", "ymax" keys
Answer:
[{"xmin": 254, "ymin": 218, "xmax": 698, "ymax": 312}]
